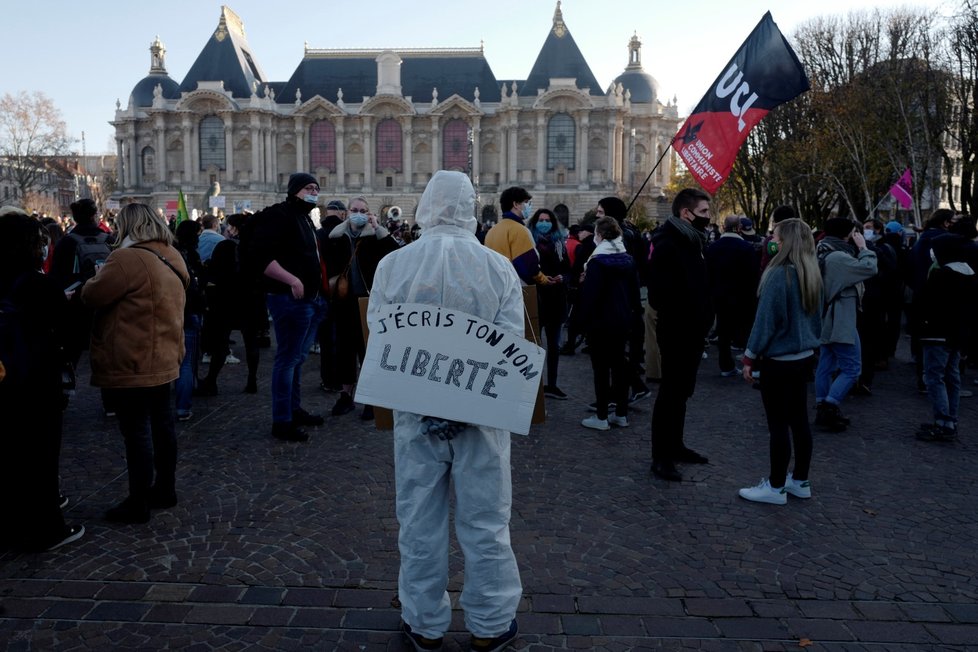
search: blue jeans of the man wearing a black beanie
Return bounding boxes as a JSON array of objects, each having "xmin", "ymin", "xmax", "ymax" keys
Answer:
[{"xmin": 266, "ymin": 294, "xmax": 326, "ymax": 423}]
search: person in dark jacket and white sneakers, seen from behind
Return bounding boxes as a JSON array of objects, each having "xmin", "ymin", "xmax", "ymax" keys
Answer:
[{"xmin": 575, "ymin": 216, "xmax": 642, "ymax": 430}]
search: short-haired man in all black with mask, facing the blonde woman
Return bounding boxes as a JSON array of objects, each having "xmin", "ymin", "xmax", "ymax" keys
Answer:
[{"xmin": 647, "ymin": 188, "xmax": 713, "ymax": 482}]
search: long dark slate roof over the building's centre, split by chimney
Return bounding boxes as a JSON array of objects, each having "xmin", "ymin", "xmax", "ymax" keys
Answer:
[{"xmin": 275, "ymin": 50, "xmax": 500, "ymax": 104}]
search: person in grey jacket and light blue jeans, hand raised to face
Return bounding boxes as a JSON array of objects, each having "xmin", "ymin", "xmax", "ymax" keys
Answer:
[{"xmin": 812, "ymin": 217, "xmax": 877, "ymax": 432}]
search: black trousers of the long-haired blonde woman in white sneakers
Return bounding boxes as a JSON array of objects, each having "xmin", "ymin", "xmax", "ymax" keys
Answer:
[{"xmin": 761, "ymin": 356, "xmax": 815, "ymax": 487}]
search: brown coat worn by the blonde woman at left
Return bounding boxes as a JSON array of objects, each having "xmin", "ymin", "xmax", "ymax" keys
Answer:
[{"xmin": 81, "ymin": 242, "xmax": 189, "ymax": 387}]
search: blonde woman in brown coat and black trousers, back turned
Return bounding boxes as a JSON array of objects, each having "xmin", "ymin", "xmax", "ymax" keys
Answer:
[{"xmin": 81, "ymin": 204, "xmax": 190, "ymax": 523}]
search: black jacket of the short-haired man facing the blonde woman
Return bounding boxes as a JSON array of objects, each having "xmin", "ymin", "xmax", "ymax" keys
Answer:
[{"xmin": 648, "ymin": 222, "xmax": 713, "ymax": 346}]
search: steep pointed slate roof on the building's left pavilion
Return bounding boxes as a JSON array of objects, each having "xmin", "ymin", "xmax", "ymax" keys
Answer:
[{"xmin": 180, "ymin": 7, "xmax": 267, "ymax": 98}]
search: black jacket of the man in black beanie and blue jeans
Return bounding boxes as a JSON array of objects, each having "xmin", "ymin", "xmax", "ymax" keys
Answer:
[{"xmin": 242, "ymin": 195, "xmax": 323, "ymax": 299}]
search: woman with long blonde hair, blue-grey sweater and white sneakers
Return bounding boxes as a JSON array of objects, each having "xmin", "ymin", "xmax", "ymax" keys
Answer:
[{"xmin": 740, "ymin": 218, "xmax": 822, "ymax": 505}]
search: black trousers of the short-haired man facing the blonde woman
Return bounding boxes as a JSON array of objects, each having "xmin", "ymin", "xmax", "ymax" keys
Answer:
[{"xmin": 652, "ymin": 333, "xmax": 703, "ymax": 461}]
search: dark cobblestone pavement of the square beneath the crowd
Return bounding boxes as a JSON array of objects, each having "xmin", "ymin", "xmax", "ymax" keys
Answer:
[{"xmin": 0, "ymin": 332, "xmax": 978, "ymax": 651}]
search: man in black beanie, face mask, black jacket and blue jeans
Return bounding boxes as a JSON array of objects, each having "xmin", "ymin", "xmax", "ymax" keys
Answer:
[{"xmin": 246, "ymin": 172, "xmax": 326, "ymax": 441}]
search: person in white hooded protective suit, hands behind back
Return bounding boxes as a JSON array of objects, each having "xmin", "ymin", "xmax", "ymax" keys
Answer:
[{"xmin": 368, "ymin": 170, "xmax": 523, "ymax": 650}]
